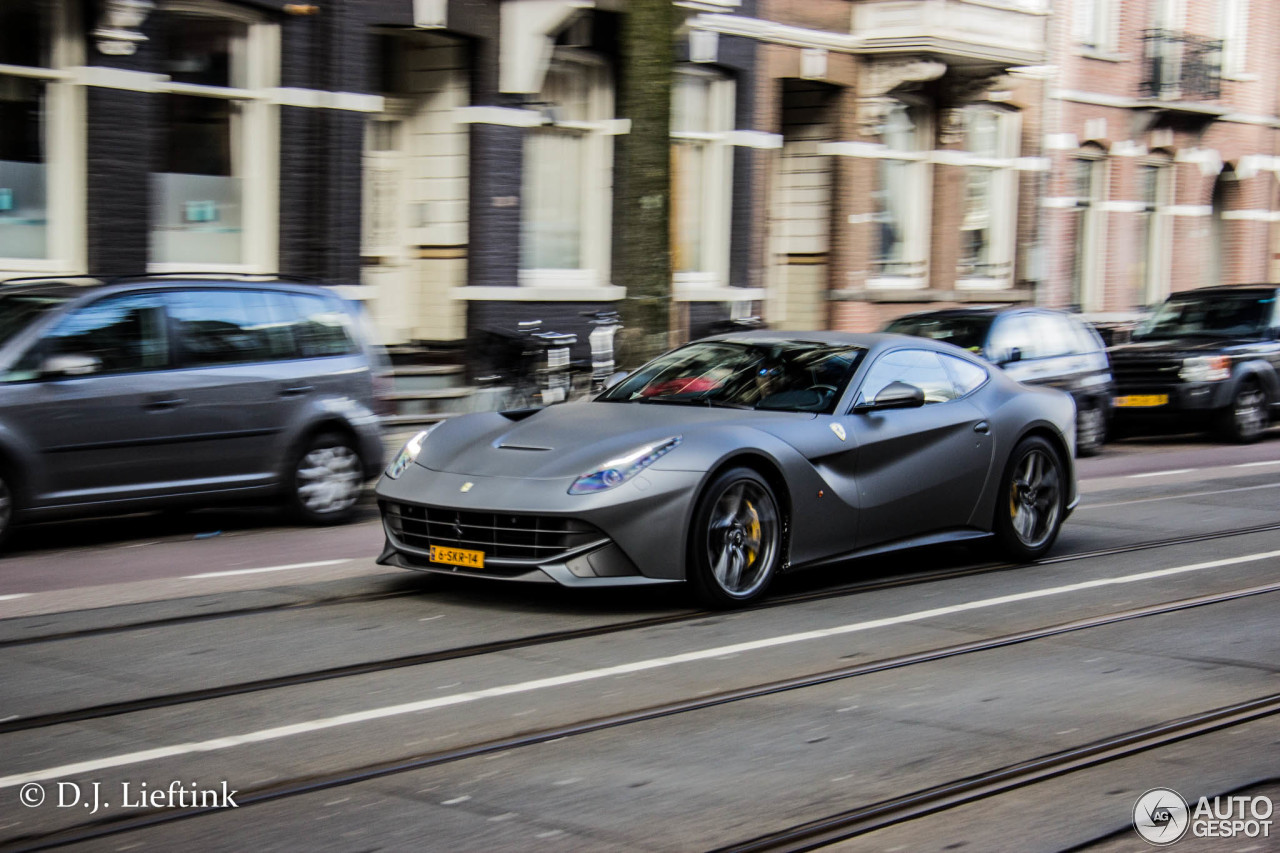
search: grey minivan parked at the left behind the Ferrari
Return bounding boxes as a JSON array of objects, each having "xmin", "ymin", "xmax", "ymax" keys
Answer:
[{"xmin": 0, "ymin": 277, "xmax": 383, "ymax": 548}]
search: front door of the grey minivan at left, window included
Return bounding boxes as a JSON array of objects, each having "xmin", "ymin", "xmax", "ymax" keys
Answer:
[{"xmin": 5, "ymin": 293, "xmax": 186, "ymax": 506}]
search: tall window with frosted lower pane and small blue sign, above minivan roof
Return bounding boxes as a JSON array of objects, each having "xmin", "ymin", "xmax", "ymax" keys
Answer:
[{"xmin": 151, "ymin": 4, "xmax": 278, "ymax": 272}]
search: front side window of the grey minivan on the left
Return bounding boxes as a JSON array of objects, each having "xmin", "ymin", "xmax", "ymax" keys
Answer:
[{"xmin": 9, "ymin": 293, "xmax": 169, "ymax": 379}]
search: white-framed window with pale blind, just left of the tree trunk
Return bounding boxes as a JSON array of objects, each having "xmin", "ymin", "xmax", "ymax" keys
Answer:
[{"xmin": 520, "ymin": 51, "xmax": 612, "ymax": 287}]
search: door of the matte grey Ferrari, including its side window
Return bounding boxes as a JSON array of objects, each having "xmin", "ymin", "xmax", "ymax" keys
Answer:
[{"xmin": 844, "ymin": 348, "xmax": 993, "ymax": 547}]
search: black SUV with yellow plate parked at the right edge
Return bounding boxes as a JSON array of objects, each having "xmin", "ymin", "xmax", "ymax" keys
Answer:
[{"xmin": 1111, "ymin": 284, "xmax": 1280, "ymax": 442}]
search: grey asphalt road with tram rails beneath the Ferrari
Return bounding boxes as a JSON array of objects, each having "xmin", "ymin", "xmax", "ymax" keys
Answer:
[{"xmin": 0, "ymin": 435, "xmax": 1280, "ymax": 852}]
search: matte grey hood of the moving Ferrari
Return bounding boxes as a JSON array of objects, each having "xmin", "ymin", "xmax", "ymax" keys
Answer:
[{"xmin": 417, "ymin": 402, "xmax": 813, "ymax": 479}]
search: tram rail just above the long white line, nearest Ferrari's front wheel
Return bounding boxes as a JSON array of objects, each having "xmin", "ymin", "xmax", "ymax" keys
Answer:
[{"xmin": 0, "ymin": 524, "xmax": 1280, "ymax": 735}]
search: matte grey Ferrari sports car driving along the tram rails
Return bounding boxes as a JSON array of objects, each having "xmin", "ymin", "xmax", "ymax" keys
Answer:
[{"xmin": 378, "ymin": 332, "xmax": 1078, "ymax": 607}]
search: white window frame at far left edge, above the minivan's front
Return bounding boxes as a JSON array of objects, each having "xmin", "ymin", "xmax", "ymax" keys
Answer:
[{"xmin": 0, "ymin": 0, "xmax": 88, "ymax": 272}]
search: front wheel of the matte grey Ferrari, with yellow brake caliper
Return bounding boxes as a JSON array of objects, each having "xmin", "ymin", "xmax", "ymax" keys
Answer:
[{"xmin": 687, "ymin": 467, "xmax": 783, "ymax": 607}]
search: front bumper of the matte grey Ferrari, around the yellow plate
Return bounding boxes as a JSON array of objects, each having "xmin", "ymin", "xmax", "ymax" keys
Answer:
[{"xmin": 376, "ymin": 465, "xmax": 701, "ymax": 587}]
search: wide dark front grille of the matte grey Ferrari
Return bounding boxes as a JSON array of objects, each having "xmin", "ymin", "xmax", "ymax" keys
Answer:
[{"xmin": 380, "ymin": 501, "xmax": 607, "ymax": 561}]
